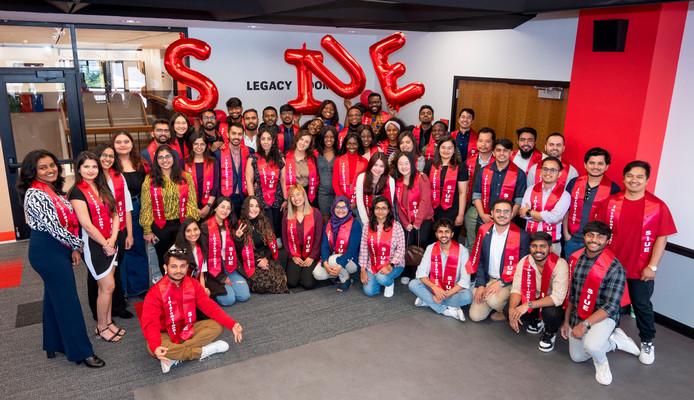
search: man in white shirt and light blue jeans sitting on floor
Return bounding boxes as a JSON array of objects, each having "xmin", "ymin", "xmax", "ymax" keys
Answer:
[{"xmin": 409, "ymin": 218, "xmax": 472, "ymax": 321}]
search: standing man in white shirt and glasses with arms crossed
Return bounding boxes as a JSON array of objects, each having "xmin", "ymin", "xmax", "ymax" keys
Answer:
[{"xmin": 518, "ymin": 156, "xmax": 571, "ymax": 255}]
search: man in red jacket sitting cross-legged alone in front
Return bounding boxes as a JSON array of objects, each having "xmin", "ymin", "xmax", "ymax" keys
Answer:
[{"xmin": 142, "ymin": 247, "xmax": 243, "ymax": 373}]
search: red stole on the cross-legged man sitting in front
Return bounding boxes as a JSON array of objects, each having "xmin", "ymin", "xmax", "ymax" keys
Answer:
[{"xmin": 157, "ymin": 275, "xmax": 197, "ymax": 343}]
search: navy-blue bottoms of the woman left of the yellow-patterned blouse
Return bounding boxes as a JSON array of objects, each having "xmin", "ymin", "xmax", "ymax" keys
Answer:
[{"xmin": 120, "ymin": 197, "xmax": 149, "ymax": 297}]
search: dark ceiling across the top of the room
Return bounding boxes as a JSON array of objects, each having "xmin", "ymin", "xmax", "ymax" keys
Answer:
[{"xmin": 0, "ymin": 0, "xmax": 680, "ymax": 32}]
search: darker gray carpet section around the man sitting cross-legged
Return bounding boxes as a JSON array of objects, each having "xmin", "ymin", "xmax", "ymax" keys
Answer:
[{"xmin": 0, "ymin": 242, "xmax": 425, "ymax": 399}]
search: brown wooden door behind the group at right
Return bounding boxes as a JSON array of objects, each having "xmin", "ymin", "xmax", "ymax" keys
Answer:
[{"xmin": 455, "ymin": 80, "xmax": 569, "ymax": 150}]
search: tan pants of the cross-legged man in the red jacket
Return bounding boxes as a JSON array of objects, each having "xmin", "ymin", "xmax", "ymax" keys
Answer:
[{"xmin": 147, "ymin": 319, "xmax": 224, "ymax": 361}]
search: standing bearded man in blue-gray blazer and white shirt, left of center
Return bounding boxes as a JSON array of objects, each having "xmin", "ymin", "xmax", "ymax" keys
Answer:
[{"xmin": 214, "ymin": 122, "xmax": 257, "ymax": 217}]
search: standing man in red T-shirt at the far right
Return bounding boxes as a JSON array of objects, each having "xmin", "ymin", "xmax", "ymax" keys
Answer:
[{"xmin": 600, "ymin": 161, "xmax": 677, "ymax": 364}]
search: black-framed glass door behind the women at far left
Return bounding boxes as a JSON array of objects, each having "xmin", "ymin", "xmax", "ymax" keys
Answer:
[{"xmin": 0, "ymin": 68, "xmax": 86, "ymax": 240}]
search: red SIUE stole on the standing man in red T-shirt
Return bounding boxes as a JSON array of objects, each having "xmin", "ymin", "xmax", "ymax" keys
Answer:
[{"xmin": 605, "ymin": 191, "xmax": 660, "ymax": 265}]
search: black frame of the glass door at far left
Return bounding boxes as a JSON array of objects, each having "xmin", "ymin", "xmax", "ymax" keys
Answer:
[{"xmin": 0, "ymin": 68, "xmax": 87, "ymax": 240}]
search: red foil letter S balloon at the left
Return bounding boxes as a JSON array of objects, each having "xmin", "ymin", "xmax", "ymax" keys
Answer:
[{"xmin": 164, "ymin": 34, "xmax": 219, "ymax": 116}]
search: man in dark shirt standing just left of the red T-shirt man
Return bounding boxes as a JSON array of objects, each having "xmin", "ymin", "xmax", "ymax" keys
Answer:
[{"xmin": 562, "ymin": 147, "xmax": 621, "ymax": 259}]
